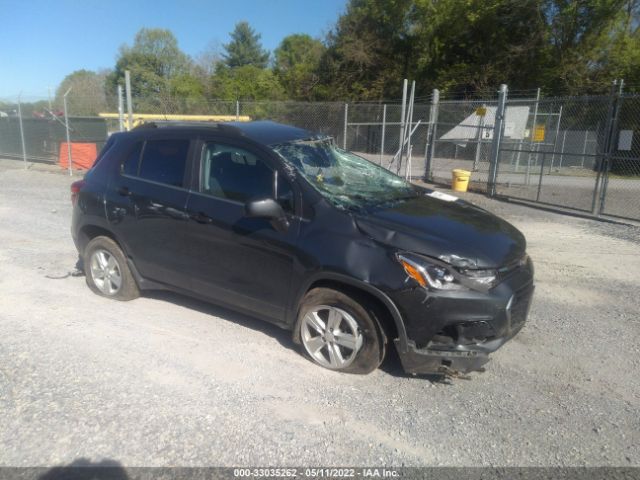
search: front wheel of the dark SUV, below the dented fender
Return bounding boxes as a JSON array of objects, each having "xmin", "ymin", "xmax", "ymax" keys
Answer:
[{"xmin": 294, "ymin": 288, "xmax": 386, "ymax": 374}]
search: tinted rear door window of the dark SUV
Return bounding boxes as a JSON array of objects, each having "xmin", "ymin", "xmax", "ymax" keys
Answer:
[{"xmin": 138, "ymin": 140, "xmax": 189, "ymax": 187}]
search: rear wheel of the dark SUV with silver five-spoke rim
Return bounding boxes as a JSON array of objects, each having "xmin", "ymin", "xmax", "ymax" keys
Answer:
[{"xmin": 83, "ymin": 237, "xmax": 140, "ymax": 301}]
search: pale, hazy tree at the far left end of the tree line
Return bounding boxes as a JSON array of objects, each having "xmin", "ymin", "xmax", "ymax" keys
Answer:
[{"xmin": 55, "ymin": 70, "xmax": 107, "ymax": 115}]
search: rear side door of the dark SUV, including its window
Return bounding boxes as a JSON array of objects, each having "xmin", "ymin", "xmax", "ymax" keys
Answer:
[{"xmin": 106, "ymin": 137, "xmax": 192, "ymax": 288}]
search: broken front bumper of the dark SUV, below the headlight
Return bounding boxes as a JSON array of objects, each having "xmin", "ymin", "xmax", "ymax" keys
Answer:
[{"xmin": 395, "ymin": 261, "xmax": 534, "ymax": 374}]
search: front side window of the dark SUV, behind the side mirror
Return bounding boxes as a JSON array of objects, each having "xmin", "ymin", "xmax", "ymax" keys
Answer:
[{"xmin": 201, "ymin": 143, "xmax": 274, "ymax": 202}]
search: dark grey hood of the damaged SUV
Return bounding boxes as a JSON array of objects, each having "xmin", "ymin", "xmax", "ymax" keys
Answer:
[{"xmin": 355, "ymin": 192, "xmax": 526, "ymax": 268}]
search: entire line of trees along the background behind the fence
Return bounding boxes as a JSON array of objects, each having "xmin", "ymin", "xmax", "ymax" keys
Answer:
[{"xmin": 26, "ymin": 0, "xmax": 640, "ymax": 114}]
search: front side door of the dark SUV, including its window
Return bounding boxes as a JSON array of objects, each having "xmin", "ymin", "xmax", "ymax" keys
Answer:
[{"xmin": 181, "ymin": 139, "xmax": 299, "ymax": 322}]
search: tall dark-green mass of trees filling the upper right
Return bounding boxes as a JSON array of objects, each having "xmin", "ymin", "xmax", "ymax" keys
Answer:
[{"xmin": 322, "ymin": 0, "xmax": 640, "ymax": 100}]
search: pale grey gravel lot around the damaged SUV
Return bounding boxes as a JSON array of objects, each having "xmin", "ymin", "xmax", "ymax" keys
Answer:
[{"xmin": 0, "ymin": 160, "xmax": 640, "ymax": 466}]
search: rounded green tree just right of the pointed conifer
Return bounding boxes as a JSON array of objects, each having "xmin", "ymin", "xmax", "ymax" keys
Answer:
[{"xmin": 274, "ymin": 34, "xmax": 325, "ymax": 100}]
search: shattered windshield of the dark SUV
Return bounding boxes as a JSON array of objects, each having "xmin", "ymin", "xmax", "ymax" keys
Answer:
[{"xmin": 272, "ymin": 139, "xmax": 419, "ymax": 209}]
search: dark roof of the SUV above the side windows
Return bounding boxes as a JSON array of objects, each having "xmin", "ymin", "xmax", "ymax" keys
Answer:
[{"xmin": 134, "ymin": 121, "xmax": 326, "ymax": 145}]
